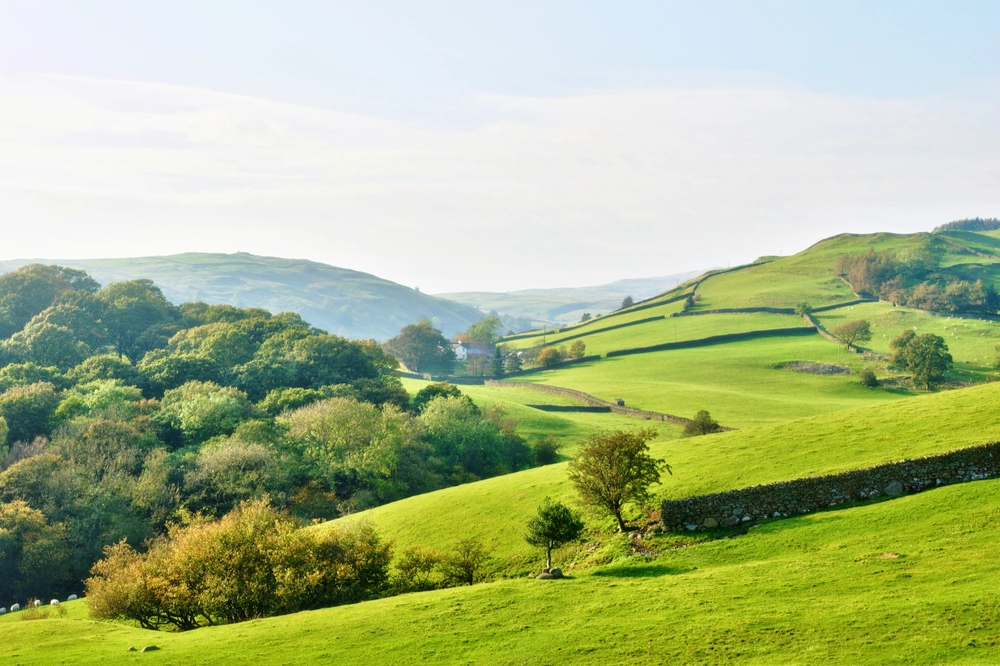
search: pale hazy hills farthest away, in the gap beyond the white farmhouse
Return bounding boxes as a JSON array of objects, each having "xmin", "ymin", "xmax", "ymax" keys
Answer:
[{"xmin": 437, "ymin": 270, "xmax": 705, "ymax": 330}]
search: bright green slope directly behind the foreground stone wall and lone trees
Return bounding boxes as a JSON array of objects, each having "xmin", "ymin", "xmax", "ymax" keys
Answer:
[{"xmin": 308, "ymin": 385, "xmax": 1000, "ymax": 575}]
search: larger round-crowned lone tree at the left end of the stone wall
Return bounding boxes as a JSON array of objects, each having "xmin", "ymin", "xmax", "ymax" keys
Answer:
[{"xmin": 569, "ymin": 429, "xmax": 672, "ymax": 532}]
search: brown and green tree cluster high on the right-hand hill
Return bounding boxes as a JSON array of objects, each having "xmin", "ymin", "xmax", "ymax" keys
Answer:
[{"xmin": 837, "ymin": 244, "xmax": 1000, "ymax": 314}]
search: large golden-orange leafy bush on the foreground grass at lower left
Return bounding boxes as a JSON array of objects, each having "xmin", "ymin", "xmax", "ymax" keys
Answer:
[{"xmin": 86, "ymin": 501, "xmax": 391, "ymax": 630}]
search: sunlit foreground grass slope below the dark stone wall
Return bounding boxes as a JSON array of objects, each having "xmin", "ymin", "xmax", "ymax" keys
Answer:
[{"xmin": 0, "ymin": 480, "xmax": 1000, "ymax": 665}]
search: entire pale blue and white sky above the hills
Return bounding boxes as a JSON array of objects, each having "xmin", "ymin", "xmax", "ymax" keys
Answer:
[{"xmin": 0, "ymin": 0, "xmax": 1000, "ymax": 293}]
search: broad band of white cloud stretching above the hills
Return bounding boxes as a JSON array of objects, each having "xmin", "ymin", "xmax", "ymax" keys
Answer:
[{"xmin": 0, "ymin": 77, "xmax": 1000, "ymax": 291}]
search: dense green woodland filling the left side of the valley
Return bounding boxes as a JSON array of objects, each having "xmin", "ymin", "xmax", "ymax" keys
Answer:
[{"xmin": 0, "ymin": 266, "xmax": 534, "ymax": 603}]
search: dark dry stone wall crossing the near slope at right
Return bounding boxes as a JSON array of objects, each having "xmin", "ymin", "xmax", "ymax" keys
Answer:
[{"xmin": 660, "ymin": 442, "xmax": 1000, "ymax": 532}]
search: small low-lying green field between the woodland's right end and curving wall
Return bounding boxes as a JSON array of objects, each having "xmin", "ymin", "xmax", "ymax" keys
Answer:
[{"xmin": 403, "ymin": 379, "xmax": 683, "ymax": 456}]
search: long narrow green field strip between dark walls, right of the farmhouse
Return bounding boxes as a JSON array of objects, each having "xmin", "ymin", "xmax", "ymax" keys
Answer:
[{"xmin": 508, "ymin": 308, "xmax": 806, "ymax": 355}]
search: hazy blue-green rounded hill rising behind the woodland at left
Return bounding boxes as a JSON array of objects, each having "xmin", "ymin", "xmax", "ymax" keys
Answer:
[{"xmin": 0, "ymin": 252, "xmax": 482, "ymax": 340}]
